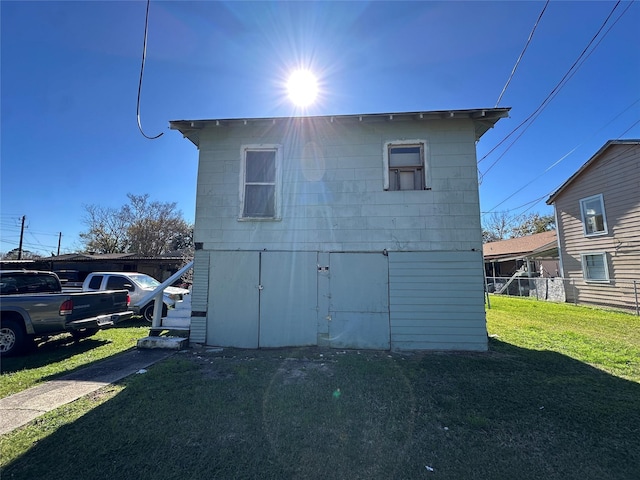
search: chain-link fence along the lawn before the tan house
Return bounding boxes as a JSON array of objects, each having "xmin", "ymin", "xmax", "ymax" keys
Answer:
[{"xmin": 486, "ymin": 276, "xmax": 640, "ymax": 315}]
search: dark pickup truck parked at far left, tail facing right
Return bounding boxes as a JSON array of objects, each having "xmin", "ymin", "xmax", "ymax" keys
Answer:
[{"xmin": 0, "ymin": 270, "xmax": 133, "ymax": 356}]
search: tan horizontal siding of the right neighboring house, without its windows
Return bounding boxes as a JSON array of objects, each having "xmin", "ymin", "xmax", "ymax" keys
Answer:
[{"xmin": 554, "ymin": 144, "xmax": 640, "ymax": 309}]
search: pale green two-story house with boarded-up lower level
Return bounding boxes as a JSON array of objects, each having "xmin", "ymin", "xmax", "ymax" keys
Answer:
[{"xmin": 170, "ymin": 108, "xmax": 509, "ymax": 351}]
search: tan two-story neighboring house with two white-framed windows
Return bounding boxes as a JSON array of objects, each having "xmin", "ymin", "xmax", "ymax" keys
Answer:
[{"xmin": 547, "ymin": 140, "xmax": 640, "ymax": 309}]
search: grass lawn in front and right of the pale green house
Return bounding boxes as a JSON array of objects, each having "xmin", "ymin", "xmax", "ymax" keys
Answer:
[{"xmin": 0, "ymin": 297, "xmax": 640, "ymax": 480}]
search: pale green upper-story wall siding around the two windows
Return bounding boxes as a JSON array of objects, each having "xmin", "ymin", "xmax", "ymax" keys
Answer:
[{"xmin": 195, "ymin": 119, "xmax": 482, "ymax": 251}]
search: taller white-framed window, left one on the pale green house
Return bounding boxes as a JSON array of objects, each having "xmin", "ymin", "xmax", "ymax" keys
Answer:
[{"xmin": 240, "ymin": 145, "xmax": 280, "ymax": 220}]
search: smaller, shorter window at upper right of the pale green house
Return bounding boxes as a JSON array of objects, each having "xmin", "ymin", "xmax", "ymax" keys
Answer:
[{"xmin": 383, "ymin": 140, "xmax": 429, "ymax": 190}]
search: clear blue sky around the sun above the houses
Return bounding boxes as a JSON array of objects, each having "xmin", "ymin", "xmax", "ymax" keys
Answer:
[{"xmin": 0, "ymin": 0, "xmax": 640, "ymax": 255}]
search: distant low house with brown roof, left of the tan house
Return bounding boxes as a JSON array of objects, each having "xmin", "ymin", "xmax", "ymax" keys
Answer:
[{"xmin": 482, "ymin": 230, "xmax": 560, "ymax": 277}]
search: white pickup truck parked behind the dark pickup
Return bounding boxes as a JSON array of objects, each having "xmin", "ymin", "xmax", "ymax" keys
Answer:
[{"xmin": 82, "ymin": 272, "xmax": 189, "ymax": 322}]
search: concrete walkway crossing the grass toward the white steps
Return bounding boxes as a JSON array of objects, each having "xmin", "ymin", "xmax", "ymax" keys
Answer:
[{"xmin": 0, "ymin": 349, "xmax": 176, "ymax": 435}]
